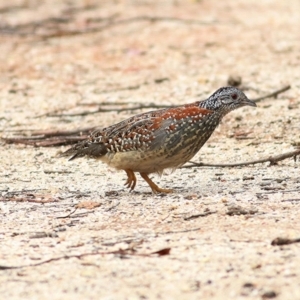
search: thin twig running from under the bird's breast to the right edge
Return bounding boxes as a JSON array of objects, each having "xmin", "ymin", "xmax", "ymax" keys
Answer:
[{"xmin": 181, "ymin": 149, "xmax": 300, "ymax": 169}]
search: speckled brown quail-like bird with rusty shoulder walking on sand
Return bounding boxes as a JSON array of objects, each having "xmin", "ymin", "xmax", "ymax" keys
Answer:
[{"xmin": 61, "ymin": 86, "xmax": 256, "ymax": 193}]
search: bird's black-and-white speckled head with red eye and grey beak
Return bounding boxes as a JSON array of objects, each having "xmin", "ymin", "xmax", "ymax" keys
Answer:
[{"xmin": 201, "ymin": 87, "xmax": 256, "ymax": 115}]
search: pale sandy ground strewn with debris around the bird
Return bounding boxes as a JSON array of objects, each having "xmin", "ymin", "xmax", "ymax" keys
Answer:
[{"xmin": 0, "ymin": 0, "xmax": 300, "ymax": 299}]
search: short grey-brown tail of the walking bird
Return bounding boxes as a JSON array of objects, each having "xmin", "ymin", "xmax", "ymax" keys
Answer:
[{"xmin": 60, "ymin": 141, "xmax": 107, "ymax": 160}]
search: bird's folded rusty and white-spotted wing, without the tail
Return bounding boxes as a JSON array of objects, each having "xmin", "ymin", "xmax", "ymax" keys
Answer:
[{"xmin": 106, "ymin": 103, "xmax": 213, "ymax": 151}]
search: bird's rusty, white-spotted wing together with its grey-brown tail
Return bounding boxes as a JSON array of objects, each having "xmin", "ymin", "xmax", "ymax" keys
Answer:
[{"xmin": 62, "ymin": 103, "xmax": 213, "ymax": 159}]
